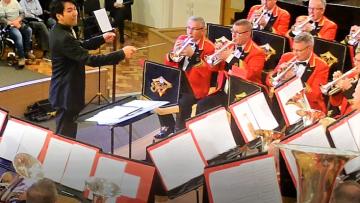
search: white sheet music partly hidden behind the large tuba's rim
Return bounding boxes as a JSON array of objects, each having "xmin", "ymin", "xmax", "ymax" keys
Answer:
[{"xmin": 284, "ymin": 125, "xmax": 330, "ymax": 183}]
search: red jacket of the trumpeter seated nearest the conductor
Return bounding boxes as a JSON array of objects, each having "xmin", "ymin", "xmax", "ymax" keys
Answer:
[{"xmin": 165, "ymin": 35, "xmax": 215, "ymax": 99}]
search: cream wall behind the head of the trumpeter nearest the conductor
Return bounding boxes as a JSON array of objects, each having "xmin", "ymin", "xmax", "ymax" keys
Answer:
[{"xmin": 132, "ymin": 0, "xmax": 221, "ymax": 28}]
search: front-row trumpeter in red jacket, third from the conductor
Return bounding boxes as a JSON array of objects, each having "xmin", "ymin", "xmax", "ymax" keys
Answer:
[{"xmin": 266, "ymin": 32, "xmax": 329, "ymax": 113}]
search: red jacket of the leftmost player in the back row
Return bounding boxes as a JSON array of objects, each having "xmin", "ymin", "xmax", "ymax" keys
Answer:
[{"xmin": 247, "ymin": 5, "xmax": 290, "ymax": 36}]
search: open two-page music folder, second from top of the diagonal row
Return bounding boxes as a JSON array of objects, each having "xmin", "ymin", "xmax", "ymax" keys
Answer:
[{"xmin": 229, "ymin": 91, "xmax": 279, "ymax": 143}]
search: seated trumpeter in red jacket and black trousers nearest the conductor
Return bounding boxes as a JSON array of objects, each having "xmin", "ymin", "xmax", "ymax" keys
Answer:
[{"xmin": 155, "ymin": 17, "xmax": 215, "ymax": 139}]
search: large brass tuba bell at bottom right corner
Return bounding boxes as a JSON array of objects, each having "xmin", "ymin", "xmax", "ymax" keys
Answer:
[{"xmin": 275, "ymin": 144, "xmax": 360, "ymax": 203}]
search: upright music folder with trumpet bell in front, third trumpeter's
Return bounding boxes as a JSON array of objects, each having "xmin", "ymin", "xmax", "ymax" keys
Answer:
[{"xmin": 275, "ymin": 77, "xmax": 310, "ymax": 126}]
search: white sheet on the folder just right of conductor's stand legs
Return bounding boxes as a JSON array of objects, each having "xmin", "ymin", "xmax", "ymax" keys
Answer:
[{"xmin": 150, "ymin": 132, "xmax": 205, "ymax": 191}]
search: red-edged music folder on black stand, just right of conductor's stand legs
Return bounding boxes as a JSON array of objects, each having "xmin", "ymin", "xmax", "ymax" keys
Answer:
[{"xmin": 147, "ymin": 130, "xmax": 206, "ymax": 198}]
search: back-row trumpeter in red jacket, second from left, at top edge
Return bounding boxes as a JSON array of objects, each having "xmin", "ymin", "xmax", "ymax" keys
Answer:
[{"xmin": 286, "ymin": 0, "xmax": 337, "ymax": 40}]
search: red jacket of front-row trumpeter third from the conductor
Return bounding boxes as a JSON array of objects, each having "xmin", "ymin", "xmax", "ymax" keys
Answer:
[{"xmin": 266, "ymin": 52, "xmax": 329, "ymax": 113}]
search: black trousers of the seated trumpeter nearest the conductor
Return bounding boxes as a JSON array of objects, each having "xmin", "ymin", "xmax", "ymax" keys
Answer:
[{"xmin": 158, "ymin": 93, "xmax": 198, "ymax": 130}]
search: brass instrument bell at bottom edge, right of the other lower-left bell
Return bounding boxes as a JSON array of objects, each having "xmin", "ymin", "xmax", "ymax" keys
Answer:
[{"xmin": 85, "ymin": 176, "xmax": 120, "ymax": 203}]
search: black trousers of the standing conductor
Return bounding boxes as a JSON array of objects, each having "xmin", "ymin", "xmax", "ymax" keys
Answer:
[{"xmin": 55, "ymin": 109, "xmax": 79, "ymax": 139}]
